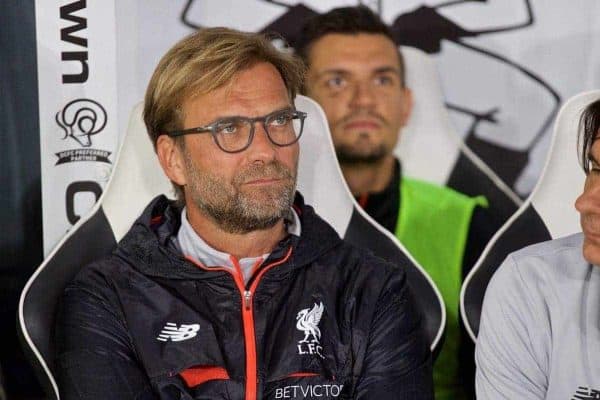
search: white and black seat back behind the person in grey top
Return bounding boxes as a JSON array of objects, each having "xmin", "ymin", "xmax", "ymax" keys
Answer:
[{"xmin": 460, "ymin": 90, "xmax": 600, "ymax": 340}]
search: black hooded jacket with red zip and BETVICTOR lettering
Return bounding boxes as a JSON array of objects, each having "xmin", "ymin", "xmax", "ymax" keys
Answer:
[{"xmin": 56, "ymin": 196, "xmax": 433, "ymax": 400}]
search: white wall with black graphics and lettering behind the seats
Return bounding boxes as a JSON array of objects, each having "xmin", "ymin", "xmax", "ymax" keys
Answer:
[{"xmin": 36, "ymin": 0, "xmax": 600, "ymax": 252}]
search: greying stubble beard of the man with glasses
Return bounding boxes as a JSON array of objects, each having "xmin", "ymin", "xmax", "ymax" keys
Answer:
[{"xmin": 185, "ymin": 155, "xmax": 297, "ymax": 234}]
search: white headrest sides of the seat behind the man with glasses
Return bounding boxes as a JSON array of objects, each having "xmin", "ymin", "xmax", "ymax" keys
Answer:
[{"xmin": 101, "ymin": 96, "xmax": 353, "ymax": 240}]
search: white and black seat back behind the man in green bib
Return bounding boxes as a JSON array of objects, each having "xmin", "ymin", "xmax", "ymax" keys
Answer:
[{"xmin": 394, "ymin": 46, "xmax": 522, "ymax": 228}]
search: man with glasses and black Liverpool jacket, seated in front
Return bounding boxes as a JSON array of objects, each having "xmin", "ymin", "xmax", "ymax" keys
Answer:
[{"xmin": 56, "ymin": 28, "xmax": 432, "ymax": 400}]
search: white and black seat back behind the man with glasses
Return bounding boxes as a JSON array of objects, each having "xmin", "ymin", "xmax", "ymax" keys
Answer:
[{"xmin": 19, "ymin": 96, "xmax": 445, "ymax": 399}]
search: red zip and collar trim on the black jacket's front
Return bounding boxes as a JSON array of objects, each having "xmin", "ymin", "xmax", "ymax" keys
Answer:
[{"xmin": 187, "ymin": 246, "xmax": 292, "ymax": 400}]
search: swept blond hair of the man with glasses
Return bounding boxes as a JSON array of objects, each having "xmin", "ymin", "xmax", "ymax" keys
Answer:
[{"xmin": 144, "ymin": 28, "xmax": 304, "ymax": 148}]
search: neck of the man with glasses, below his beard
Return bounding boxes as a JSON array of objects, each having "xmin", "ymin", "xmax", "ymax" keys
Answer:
[{"xmin": 186, "ymin": 205, "xmax": 286, "ymax": 260}]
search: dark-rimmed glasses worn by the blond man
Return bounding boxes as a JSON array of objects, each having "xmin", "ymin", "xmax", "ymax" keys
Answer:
[{"xmin": 166, "ymin": 108, "xmax": 306, "ymax": 153}]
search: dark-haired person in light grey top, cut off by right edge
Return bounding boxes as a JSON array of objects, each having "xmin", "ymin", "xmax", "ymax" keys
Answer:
[{"xmin": 475, "ymin": 100, "xmax": 600, "ymax": 400}]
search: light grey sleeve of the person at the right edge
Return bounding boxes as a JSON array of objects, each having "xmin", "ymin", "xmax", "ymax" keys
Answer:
[{"xmin": 475, "ymin": 256, "xmax": 551, "ymax": 400}]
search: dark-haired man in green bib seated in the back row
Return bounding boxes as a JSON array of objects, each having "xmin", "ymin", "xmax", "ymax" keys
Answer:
[{"xmin": 297, "ymin": 6, "xmax": 494, "ymax": 400}]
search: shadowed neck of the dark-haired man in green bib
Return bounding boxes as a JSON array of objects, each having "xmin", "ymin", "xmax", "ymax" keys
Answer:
[{"xmin": 341, "ymin": 155, "xmax": 395, "ymax": 196}]
